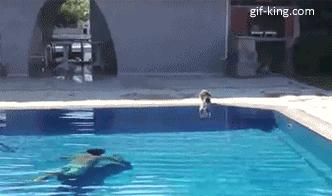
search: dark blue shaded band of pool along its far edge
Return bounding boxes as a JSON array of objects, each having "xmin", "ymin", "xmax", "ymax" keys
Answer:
[{"xmin": 0, "ymin": 105, "xmax": 275, "ymax": 135}]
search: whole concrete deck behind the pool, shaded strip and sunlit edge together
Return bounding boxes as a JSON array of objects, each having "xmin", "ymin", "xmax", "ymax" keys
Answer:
[{"xmin": 0, "ymin": 74, "xmax": 332, "ymax": 140}]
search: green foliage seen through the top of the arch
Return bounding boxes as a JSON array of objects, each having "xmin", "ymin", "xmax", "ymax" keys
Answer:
[{"xmin": 60, "ymin": 0, "xmax": 90, "ymax": 23}]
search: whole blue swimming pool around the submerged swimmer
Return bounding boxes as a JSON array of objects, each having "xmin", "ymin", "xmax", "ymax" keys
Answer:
[{"xmin": 0, "ymin": 106, "xmax": 332, "ymax": 196}]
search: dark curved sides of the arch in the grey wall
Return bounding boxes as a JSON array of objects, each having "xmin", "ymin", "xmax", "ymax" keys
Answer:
[{"xmin": 28, "ymin": 0, "xmax": 117, "ymax": 77}]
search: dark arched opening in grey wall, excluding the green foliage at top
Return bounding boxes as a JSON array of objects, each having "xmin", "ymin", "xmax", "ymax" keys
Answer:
[{"xmin": 29, "ymin": 0, "xmax": 117, "ymax": 77}]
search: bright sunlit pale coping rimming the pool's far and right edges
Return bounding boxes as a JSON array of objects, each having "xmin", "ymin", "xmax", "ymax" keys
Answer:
[{"xmin": 0, "ymin": 98, "xmax": 332, "ymax": 142}]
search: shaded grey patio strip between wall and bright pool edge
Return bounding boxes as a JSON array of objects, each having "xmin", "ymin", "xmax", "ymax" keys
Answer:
[{"xmin": 0, "ymin": 74, "xmax": 331, "ymax": 102}]
